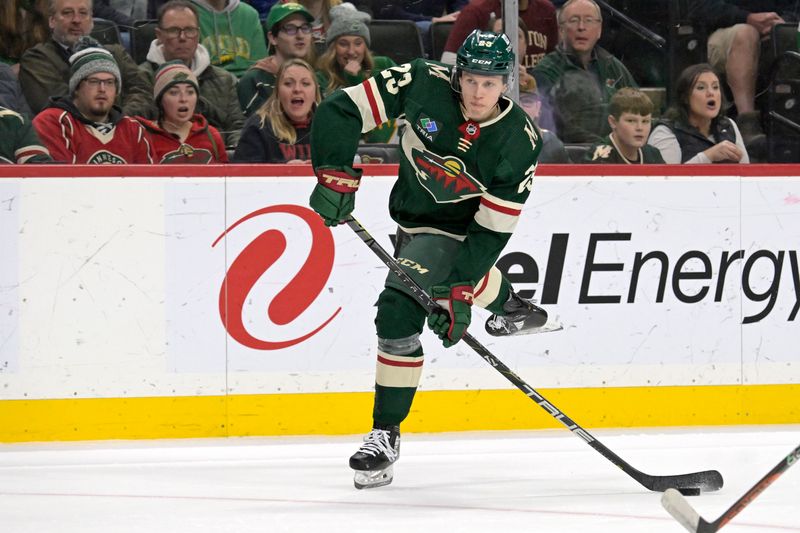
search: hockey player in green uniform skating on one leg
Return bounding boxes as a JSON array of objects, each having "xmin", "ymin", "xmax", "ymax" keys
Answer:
[{"xmin": 310, "ymin": 30, "xmax": 546, "ymax": 488}]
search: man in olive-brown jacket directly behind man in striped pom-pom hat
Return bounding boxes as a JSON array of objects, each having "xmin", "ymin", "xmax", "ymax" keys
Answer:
[{"xmin": 19, "ymin": 0, "xmax": 155, "ymax": 115}]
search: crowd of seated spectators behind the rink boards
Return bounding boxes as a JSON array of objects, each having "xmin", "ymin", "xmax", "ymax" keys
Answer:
[{"xmin": 0, "ymin": 0, "xmax": 800, "ymax": 163}]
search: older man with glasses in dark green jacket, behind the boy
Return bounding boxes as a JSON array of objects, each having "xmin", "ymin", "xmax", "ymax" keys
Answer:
[{"xmin": 531, "ymin": 0, "xmax": 638, "ymax": 143}]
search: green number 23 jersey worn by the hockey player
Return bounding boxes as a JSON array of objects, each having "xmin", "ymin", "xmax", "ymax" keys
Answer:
[{"xmin": 311, "ymin": 59, "xmax": 542, "ymax": 282}]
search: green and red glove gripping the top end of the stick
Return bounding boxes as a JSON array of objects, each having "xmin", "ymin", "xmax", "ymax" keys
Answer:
[{"xmin": 309, "ymin": 167, "xmax": 361, "ymax": 226}]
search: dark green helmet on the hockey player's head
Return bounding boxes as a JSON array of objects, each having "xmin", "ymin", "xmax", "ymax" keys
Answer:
[{"xmin": 450, "ymin": 30, "xmax": 515, "ymax": 93}]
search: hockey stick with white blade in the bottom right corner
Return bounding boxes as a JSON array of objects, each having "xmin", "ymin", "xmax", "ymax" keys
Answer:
[{"xmin": 661, "ymin": 440, "xmax": 800, "ymax": 533}]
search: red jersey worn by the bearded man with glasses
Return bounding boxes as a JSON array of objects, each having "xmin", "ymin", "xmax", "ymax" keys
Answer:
[{"xmin": 33, "ymin": 97, "xmax": 154, "ymax": 165}]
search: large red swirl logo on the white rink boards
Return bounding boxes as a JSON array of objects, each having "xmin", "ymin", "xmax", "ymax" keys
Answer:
[{"xmin": 211, "ymin": 204, "xmax": 342, "ymax": 350}]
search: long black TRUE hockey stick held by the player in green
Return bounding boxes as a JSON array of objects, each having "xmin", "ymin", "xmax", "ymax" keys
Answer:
[{"xmin": 345, "ymin": 217, "xmax": 722, "ymax": 494}]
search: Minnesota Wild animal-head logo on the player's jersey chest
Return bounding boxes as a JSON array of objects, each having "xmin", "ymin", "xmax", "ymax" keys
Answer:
[{"xmin": 411, "ymin": 148, "xmax": 486, "ymax": 204}]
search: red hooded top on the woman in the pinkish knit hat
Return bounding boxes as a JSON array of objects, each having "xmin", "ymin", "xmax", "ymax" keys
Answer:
[{"xmin": 136, "ymin": 114, "xmax": 228, "ymax": 165}]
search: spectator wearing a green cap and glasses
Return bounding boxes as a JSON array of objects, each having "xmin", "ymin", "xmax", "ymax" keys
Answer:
[{"xmin": 236, "ymin": 2, "xmax": 314, "ymax": 117}]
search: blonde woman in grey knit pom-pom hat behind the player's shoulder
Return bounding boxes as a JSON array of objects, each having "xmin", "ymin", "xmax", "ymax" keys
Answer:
[{"xmin": 317, "ymin": 4, "xmax": 397, "ymax": 143}]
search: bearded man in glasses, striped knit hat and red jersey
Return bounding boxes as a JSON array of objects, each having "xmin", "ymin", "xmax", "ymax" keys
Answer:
[{"xmin": 33, "ymin": 37, "xmax": 153, "ymax": 164}]
